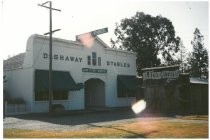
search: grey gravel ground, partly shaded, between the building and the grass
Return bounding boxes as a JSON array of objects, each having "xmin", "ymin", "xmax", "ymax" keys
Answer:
[{"xmin": 3, "ymin": 109, "xmax": 207, "ymax": 131}]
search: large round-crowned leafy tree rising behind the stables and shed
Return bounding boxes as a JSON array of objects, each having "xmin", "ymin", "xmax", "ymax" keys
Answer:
[{"xmin": 111, "ymin": 12, "xmax": 180, "ymax": 75}]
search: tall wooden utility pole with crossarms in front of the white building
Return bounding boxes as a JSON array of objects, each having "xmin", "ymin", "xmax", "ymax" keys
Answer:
[{"xmin": 38, "ymin": 1, "xmax": 61, "ymax": 113}]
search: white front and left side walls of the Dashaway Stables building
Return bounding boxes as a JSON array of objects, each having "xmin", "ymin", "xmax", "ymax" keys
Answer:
[{"xmin": 8, "ymin": 35, "xmax": 136, "ymax": 112}]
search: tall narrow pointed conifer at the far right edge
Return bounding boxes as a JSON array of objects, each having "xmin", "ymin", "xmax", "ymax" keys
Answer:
[{"xmin": 189, "ymin": 28, "xmax": 208, "ymax": 78}]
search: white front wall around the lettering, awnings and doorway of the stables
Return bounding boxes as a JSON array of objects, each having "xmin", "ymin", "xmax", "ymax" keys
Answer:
[{"xmin": 30, "ymin": 36, "xmax": 136, "ymax": 109}]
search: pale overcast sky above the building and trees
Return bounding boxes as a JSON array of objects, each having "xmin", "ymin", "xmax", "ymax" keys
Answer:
[{"xmin": 1, "ymin": 0, "xmax": 209, "ymax": 59}]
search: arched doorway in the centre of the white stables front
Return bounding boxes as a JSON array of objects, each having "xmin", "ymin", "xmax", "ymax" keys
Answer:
[{"xmin": 84, "ymin": 78, "xmax": 105, "ymax": 108}]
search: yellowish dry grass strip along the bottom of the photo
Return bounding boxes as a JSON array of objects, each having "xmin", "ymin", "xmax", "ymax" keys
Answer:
[{"xmin": 4, "ymin": 117, "xmax": 208, "ymax": 138}]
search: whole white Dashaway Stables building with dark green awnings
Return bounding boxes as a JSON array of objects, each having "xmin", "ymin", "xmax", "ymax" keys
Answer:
[{"xmin": 4, "ymin": 34, "xmax": 136, "ymax": 112}]
